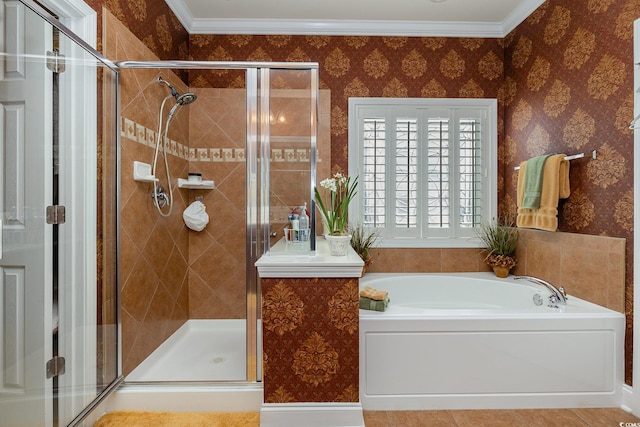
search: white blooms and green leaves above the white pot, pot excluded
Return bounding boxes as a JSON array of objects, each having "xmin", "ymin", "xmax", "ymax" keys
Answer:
[{"xmin": 314, "ymin": 173, "xmax": 358, "ymax": 236}]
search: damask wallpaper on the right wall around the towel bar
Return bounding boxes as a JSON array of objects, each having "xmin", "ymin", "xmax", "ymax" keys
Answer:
[{"xmin": 501, "ymin": 0, "xmax": 640, "ymax": 383}]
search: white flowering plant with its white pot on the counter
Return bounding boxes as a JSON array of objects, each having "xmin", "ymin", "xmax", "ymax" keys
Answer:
[{"xmin": 314, "ymin": 172, "xmax": 358, "ymax": 255}]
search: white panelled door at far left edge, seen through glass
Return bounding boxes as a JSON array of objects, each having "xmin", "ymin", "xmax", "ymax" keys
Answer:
[{"xmin": 0, "ymin": 1, "xmax": 53, "ymax": 427}]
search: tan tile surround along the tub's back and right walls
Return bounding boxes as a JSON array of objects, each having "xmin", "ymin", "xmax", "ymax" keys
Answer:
[{"xmin": 367, "ymin": 229, "xmax": 625, "ymax": 318}]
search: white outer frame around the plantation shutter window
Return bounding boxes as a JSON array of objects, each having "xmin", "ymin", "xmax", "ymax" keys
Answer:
[{"xmin": 349, "ymin": 98, "xmax": 498, "ymax": 248}]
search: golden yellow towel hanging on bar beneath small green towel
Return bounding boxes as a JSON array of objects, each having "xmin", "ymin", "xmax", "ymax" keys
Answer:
[{"xmin": 516, "ymin": 154, "xmax": 571, "ymax": 231}]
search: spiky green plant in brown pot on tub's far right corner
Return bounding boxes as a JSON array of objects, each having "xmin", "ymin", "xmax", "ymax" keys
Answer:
[{"xmin": 477, "ymin": 220, "xmax": 520, "ymax": 278}]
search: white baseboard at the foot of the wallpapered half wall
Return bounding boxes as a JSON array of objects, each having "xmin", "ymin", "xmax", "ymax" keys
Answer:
[{"xmin": 260, "ymin": 403, "xmax": 364, "ymax": 427}]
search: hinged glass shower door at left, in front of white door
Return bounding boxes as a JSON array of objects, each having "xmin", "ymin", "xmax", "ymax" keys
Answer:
[{"xmin": 0, "ymin": 1, "xmax": 118, "ymax": 426}]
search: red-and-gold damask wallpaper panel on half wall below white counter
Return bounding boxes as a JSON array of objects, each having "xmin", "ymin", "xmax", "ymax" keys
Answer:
[{"xmin": 261, "ymin": 278, "xmax": 360, "ymax": 403}]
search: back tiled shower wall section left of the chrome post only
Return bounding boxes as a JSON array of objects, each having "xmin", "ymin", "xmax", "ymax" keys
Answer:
[{"xmin": 189, "ymin": 89, "xmax": 246, "ymax": 319}]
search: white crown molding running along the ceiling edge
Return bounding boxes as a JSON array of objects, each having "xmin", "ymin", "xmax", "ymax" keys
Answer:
[{"xmin": 165, "ymin": 0, "xmax": 545, "ymax": 38}]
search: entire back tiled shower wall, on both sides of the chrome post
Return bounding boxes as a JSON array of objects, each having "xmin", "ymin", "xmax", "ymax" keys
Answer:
[{"xmin": 189, "ymin": 88, "xmax": 330, "ymax": 319}]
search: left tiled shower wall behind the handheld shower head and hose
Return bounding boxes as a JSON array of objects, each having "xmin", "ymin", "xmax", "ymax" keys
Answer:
[{"xmin": 103, "ymin": 12, "xmax": 189, "ymax": 375}]
